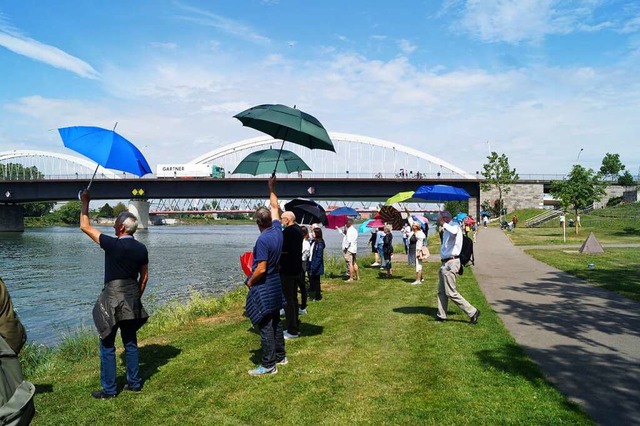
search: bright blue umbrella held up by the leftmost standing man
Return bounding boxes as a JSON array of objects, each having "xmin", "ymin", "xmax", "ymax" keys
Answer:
[{"xmin": 58, "ymin": 123, "xmax": 151, "ymax": 189}]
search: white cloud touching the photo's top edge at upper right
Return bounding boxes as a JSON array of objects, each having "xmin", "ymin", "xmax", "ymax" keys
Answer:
[{"xmin": 452, "ymin": 0, "xmax": 615, "ymax": 44}]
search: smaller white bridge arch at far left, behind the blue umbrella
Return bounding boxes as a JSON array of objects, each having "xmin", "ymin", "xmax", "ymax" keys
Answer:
[{"xmin": 0, "ymin": 150, "xmax": 122, "ymax": 179}]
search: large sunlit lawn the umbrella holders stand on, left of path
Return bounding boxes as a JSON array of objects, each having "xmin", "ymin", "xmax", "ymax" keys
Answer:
[{"xmin": 29, "ymin": 258, "xmax": 592, "ymax": 425}]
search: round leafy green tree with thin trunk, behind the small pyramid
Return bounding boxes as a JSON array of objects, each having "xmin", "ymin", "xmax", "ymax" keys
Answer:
[{"xmin": 550, "ymin": 164, "xmax": 606, "ymax": 234}]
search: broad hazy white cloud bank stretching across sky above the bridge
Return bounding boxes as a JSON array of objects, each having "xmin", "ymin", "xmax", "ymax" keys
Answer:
[{"xmin": 0, "ymin": 48, "xmax": 640, "ymax": 174}]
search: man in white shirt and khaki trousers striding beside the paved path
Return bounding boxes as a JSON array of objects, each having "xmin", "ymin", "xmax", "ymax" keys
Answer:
[{"xmin": 436, "ymin": 211, "xmax": 480, "ymax": 324}]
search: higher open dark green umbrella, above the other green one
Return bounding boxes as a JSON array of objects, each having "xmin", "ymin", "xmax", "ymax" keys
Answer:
[{"xmin": 234, "ymin": 104, "xmax": 336, "ymax": 174}]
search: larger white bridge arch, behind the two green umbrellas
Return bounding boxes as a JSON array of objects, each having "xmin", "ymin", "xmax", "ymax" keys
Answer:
[{"xmin": 190, "ymin": 132, "xmax": 477, "ymax": 179}]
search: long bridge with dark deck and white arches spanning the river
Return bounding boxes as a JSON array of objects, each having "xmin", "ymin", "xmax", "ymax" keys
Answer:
[{"xmin": 0, "ymin": 133, "xmax": 500, "ymax": 230}]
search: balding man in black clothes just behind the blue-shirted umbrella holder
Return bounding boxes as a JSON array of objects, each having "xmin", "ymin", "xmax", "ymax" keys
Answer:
[{"xmin": 280, "ymin": 211, "xmax": 304, "ymax": 339}]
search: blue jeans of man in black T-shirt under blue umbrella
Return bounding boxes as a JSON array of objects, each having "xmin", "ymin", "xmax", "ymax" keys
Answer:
[{"xmin": 100, "ymin": 320, "xmax": 142, "ymax": 395}]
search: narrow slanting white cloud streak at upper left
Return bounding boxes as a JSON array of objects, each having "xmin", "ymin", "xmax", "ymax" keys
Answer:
[{"xmin": 0, "ymin": 25, "xmax": 99, "ymax": 79}]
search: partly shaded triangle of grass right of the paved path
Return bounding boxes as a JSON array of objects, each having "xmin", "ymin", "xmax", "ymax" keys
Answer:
[{"xmin": 527, "ymin": 248, "xmax": 640, "ymax": 301}]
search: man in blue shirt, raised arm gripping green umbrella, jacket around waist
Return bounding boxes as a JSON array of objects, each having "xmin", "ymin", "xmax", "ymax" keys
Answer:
[{"xmin": 245, "ymin": 177, "xmax": 288, "ymax": 376}]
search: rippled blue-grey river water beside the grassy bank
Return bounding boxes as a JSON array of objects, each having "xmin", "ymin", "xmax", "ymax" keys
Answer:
[{"xmin": 0, "ymin": 225, "xmax": 378, "ymax": 345}]
